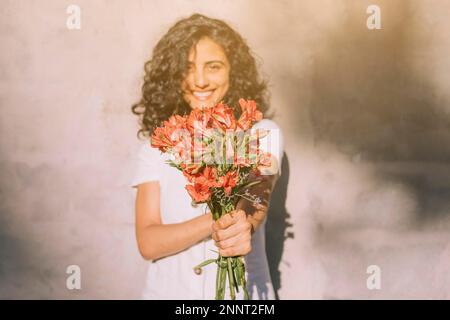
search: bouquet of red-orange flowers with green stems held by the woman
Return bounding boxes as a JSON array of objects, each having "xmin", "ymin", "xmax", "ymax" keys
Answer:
[{"xmin": 151, "ymin": 99, "xmax": 271, "ymax": 300}]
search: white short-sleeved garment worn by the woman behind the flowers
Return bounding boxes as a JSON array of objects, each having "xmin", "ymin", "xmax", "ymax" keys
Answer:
[{"xmin": 130, "ymin": 119, "xmax": 283, "ymax": 300}]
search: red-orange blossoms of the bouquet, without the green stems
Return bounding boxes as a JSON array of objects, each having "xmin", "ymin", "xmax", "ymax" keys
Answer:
[{"xmin": 151, "ymin": 99, "xmax": 271, "ymax": 203}]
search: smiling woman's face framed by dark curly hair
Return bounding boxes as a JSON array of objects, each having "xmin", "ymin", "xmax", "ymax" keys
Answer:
[{"xmin": 181, "ymin": 37, "xmax": 230, "ymax": 109}]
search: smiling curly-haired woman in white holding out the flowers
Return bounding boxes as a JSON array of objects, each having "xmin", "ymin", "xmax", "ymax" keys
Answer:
[{"xmin": 131, "ymin": 14, "xmax": 282, "ymax": 299}]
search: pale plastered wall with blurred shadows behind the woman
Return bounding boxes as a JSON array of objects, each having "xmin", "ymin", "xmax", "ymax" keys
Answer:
[{"xmin": 0, "ymin": 0, "xmax": 450, "ymax": 299}]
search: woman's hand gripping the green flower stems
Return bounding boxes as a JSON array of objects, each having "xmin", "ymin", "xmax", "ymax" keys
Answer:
[{"xmin": 212, "ymin": 210, "xmax": 252, "ymax": 257}]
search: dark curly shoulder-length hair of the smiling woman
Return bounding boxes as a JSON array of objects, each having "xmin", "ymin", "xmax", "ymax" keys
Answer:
[{"xmin": 131, "ymin": 14, "xmax": 270, "ymax": 138}]
